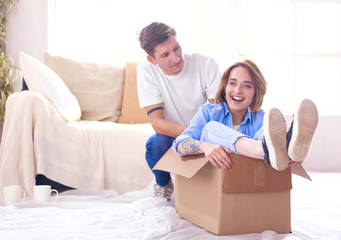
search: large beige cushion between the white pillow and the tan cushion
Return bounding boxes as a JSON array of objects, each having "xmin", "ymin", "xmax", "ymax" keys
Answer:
[{"xmin": 44, "ymin": 52, "xmax": 124, "ymax": 122}]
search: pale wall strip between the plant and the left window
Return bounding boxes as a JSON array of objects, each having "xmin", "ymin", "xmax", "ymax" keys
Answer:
[{"xmin": 6, "ymin": 0, "xmax": 48, "ymax": 91}]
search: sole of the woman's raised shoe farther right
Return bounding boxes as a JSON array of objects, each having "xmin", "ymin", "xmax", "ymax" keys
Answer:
[{"xmin": 288, "ymin": 99, "xmax": 318, "ymax": 162}]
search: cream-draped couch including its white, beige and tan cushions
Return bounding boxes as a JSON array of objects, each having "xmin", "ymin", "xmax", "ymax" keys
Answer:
[{"xmin": 0, "ymin": 52, "xmax": 154, "ymax": 196}]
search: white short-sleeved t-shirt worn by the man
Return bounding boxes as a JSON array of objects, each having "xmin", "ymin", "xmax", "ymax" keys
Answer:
[{"xmin": 137, "ymin": 53, "xmax": 221, "ymax": 126}]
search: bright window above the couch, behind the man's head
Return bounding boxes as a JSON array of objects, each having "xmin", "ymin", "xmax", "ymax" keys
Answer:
[{"xmin": 49, "ymin": 0, "xmax": 200, "ymax": 61}]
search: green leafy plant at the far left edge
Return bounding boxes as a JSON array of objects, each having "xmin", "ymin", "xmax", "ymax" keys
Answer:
[{"xmin": 0, "ymin": 0, "xmax": 17, "ymax": 123}]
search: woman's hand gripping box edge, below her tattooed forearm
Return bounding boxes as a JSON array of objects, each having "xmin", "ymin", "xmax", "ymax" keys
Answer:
[{"xmin": 200, "ymin": 142, "xmax": 233, "ymax": 169}]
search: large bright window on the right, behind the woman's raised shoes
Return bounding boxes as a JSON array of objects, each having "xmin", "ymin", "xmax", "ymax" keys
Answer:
[{"xmin": 242, "ymin": 0, "xmax": 341, "ymax": 115}]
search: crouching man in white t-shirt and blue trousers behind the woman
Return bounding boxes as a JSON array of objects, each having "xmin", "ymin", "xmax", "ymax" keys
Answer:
[{"xmin": 137, "ymin": 22, "xmax": 221, "ymax": 201}]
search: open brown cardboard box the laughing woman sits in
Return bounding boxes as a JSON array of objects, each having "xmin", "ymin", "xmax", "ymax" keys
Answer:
[{"xmin": 154, "ymin": 149, "xmax": 309, "ymax": 235}]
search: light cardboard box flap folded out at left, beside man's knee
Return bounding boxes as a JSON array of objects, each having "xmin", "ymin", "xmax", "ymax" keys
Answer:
[{"xmin": 153, "ymin": 148, "xmax": 208, "ymax": 178}]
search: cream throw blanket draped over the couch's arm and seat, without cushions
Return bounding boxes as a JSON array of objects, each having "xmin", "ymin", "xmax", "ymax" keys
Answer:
[{"xmin": 0, "ymin": 91, "xmax": 153, "ymax": 196}]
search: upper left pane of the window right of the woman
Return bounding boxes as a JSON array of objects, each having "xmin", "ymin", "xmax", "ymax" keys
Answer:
[{"xmin": 243, "ymin": 0, "xmax": 294, "ymax": 54}]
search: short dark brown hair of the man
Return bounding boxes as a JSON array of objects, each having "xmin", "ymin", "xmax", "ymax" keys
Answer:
[{"xmin": 138, "ymin": 22, "xmax": 176, "ymax": 57}]
